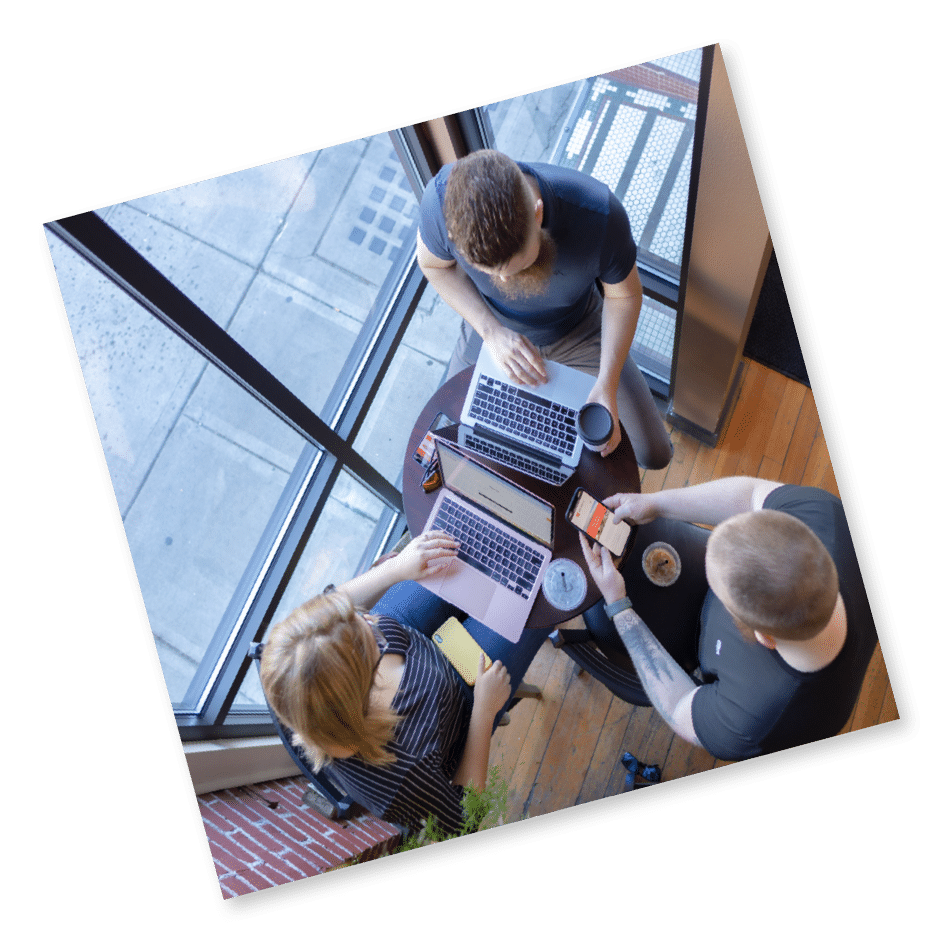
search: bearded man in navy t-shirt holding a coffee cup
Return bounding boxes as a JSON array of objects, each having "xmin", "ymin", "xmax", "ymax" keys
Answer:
[{"xmin": 418, "ymin": 150, "xmax": 672, "ymax": 468}]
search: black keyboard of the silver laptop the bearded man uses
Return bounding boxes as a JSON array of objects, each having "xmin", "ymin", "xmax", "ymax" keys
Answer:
[{"xmin": 469, "ymin": 376, "xmax": 576, "ymax": 455}]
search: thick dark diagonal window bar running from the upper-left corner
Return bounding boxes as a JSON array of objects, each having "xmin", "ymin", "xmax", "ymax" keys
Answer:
[{"xmin": 46, "ymin": 212, "xmax": 402, "ymax": 507}]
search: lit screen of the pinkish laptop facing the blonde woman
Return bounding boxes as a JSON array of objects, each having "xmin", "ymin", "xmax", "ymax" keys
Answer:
[{"xmin": 437, "ymin": 439, "xmax": 553, "ymax": 549}]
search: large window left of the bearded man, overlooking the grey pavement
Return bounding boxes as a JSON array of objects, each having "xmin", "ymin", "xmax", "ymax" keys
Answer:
[{"xmin": 47, "ymin": 134, "xmax": 459, "ymax": 724}]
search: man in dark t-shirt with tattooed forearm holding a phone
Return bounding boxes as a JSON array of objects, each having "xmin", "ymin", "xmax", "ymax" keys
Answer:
[{"xmin": 583, "ymin": 477, "xmax": 877, "ymax": 759}]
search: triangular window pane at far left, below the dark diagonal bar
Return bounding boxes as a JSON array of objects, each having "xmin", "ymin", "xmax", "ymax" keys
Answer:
[{"xmin": 49, "ymin": 236, "xmax": 312, "ymax": 702}]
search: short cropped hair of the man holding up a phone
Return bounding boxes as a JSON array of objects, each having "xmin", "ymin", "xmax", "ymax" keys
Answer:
[{"xmin": 707, "ymin": 510, "xmax": 839, "ymax": 641}]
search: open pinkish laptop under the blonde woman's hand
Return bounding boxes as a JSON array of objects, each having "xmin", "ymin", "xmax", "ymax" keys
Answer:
[{"xmin": 421, "ymin": 437, "xmax": 555, "ymax": 642}]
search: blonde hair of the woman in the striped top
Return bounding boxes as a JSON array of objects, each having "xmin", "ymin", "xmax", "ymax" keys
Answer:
[{"xmin": 261, "ymin": 592, "xmax": 399, "ymax": 770}]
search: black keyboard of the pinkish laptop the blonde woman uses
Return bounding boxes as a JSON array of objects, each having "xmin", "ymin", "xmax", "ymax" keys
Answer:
[{"xmin": 432, "ymin": 497, "xmax": 541, "ymax": 598}]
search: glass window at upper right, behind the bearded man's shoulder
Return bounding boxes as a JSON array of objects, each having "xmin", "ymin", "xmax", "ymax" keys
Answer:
[{"xmin": 488, "ymin": 49, "xmax": 702, "ymax": 391}]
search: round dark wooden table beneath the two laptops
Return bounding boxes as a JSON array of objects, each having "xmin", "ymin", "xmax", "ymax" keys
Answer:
[{"xmin": 402, "ymin": 367, "xmax": 641, "ymax": 628}]
